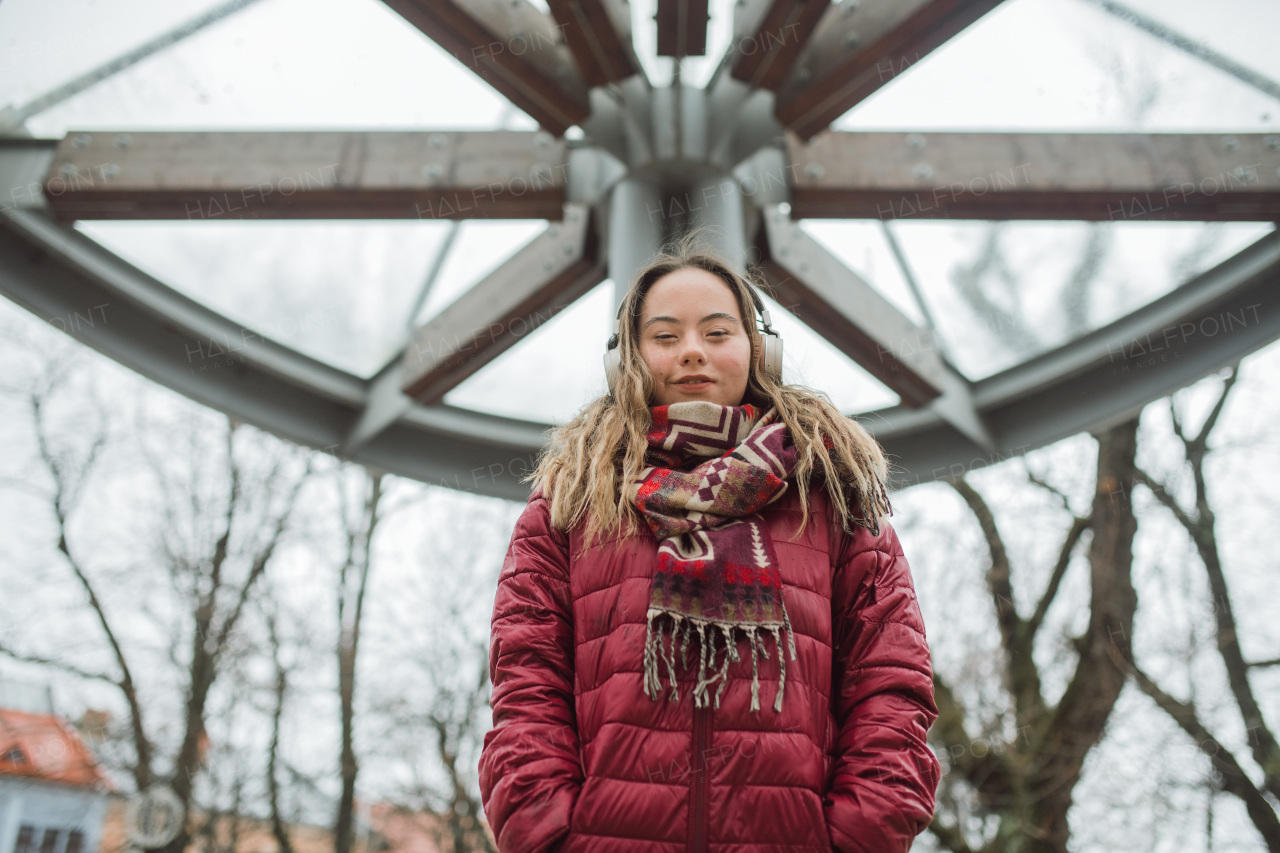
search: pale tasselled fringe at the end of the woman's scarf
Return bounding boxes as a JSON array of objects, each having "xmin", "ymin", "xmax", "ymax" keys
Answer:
[{"xmin": 644, "ymin": 603, "xmax": 796, "ymax": 713}]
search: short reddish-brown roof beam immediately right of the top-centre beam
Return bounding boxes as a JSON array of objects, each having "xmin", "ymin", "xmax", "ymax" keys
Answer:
[{"xmin": 728, "ymin": 0, "xmax": 831, "ymax": 90}]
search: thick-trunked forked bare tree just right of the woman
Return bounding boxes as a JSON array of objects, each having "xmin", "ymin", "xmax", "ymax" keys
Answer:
[{"xmin": 929, "ymin": 419, "xmax": 1138, "ymax": 853}]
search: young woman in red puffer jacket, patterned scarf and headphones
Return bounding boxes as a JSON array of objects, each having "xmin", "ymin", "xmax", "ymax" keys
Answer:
[{"xmin": 480, "ymin": 240, "xmax": 940, "ymax": 853}]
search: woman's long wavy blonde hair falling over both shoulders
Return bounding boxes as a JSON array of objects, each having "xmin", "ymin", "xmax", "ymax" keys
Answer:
[{"xmin": 521, "ymin": 231, "xmax": 893, "ymax": 549}]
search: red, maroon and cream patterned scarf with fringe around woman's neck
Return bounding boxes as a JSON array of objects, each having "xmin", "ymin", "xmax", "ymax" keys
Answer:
[{"xmin": 631, "ymin": 400, "xmax": 796, "ymax": 711}]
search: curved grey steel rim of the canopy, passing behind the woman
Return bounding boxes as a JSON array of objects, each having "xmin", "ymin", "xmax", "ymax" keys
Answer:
[{"xmin": 0, "ymin": 209, "xmax": 1280, "ymax": 501}]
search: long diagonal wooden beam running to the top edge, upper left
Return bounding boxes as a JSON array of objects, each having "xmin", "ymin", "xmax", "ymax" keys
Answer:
[{"xmin": 383, "ymin": 0, "xmax": 591, "ymax": 136}]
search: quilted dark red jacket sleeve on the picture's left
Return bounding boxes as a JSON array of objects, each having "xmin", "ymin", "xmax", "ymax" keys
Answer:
[{"xmin": 480, "ymin": 489, "xmax": 582, "ymax": 853}]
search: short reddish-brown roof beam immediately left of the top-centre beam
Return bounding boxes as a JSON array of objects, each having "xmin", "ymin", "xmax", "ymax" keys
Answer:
[{"xmin": 547, "ymin": 0, "xmax": 640, "ymax": 86}]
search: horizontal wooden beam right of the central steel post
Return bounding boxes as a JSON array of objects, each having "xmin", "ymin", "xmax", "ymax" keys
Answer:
[{"xmin": 787, "ymin": 132, "xmax": 1280, "ymax": 222}]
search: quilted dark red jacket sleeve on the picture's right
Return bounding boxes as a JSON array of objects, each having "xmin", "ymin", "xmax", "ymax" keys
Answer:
[{"xmin": 823, "ymin": 521, "xmax": 941, "ymax": 853}]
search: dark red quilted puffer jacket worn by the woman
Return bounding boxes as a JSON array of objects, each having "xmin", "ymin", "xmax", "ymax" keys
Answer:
[{"xmin": 480, "ymin": 487, "xmax": 940, "ymax": 853}]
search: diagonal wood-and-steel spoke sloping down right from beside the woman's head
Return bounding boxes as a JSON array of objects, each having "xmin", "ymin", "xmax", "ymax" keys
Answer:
[{"xmin": 756, "ymin": 205, "xmax": 995, "ymax": 450}]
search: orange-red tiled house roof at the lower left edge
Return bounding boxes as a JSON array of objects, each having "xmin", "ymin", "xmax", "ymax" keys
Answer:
[{"xmin": 0, "ymin": 708, "xmax": 115, "ymax": 790}]
